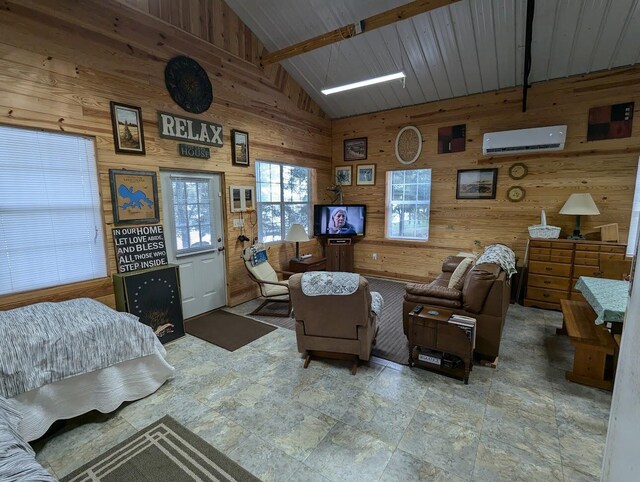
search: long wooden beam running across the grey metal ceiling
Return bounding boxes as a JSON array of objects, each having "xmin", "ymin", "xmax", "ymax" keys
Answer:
[{"xmin": 260, "ymin": 0, "xmax": 459, "ymax": 65}]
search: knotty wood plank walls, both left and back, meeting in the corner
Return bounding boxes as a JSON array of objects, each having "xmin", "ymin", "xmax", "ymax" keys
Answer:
[{"xmin": 0, "ymin": 0, "xmax": 640, "ymax": 309}]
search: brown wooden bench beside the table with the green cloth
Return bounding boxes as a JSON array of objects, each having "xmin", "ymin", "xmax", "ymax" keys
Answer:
[{"xmin": 559, "ymin": 300, "xmax": 616, "ymax": 390}]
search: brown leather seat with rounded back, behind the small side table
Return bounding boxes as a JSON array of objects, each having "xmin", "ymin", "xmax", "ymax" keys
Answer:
[{"xmin": 402, "ymin": 256, "xmax": 511, "ymax": 361}]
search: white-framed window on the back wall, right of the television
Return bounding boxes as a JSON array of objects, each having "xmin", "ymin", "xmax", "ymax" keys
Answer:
[{"xmin": 386, "ymin": 169, "xmax": 431, "ymax": 241}]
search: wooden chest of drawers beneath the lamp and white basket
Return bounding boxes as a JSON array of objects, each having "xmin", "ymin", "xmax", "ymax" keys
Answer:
[{"xmin": 524, "ymin": 239, "xmax": 627, "ymax": 310}]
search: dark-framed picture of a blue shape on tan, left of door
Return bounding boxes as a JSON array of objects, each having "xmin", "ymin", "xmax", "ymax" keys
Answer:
[{"xmin": 109, "ymin": 169, "xmax": 160, "ymax": 225}]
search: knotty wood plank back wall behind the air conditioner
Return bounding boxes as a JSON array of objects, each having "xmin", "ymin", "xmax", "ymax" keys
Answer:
[{"xmin": 332, "ymin": 67, "xmax": 640, "ymax": 280}]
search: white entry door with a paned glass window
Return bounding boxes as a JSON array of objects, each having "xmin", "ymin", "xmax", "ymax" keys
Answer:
[{"xmin": 160, "ymin": 171, "xmax": 227, "ymax": 319}]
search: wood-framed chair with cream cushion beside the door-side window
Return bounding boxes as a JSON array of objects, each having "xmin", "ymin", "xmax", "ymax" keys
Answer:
[{"xmin": 242, "ymin": 246, "xmax": 292, "ymax": 318}]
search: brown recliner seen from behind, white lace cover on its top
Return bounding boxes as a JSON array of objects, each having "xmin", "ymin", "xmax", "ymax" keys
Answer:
[{"xmin": 289, "ymin": 272, "xmax": 382, "ymax": 375}]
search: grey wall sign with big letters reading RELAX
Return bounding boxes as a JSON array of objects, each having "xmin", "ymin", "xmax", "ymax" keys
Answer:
[{"xmin": 158, "ymin": 112, "xmax": 222, "ymax": 147}]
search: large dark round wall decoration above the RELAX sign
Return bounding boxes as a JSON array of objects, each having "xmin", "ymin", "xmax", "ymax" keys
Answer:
[{"xmin": 164, "ymin": 55, "xmax": 213, "ymax": 114}]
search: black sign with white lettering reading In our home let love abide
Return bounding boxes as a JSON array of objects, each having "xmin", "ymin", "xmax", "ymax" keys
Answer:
[{"xmin": 112, "ymin": 224, "xmax": 169, "ymax": 273}]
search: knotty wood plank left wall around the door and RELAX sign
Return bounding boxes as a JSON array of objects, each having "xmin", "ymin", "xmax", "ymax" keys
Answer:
[{"xmin": 0, "ymin": 0, "xmax": 332, "ymax": 309}]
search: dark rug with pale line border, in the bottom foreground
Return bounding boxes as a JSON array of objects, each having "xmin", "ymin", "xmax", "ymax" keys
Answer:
[{"xmin": 61, "ymin": 415, "xmax": 260, "ymax": 482}]
